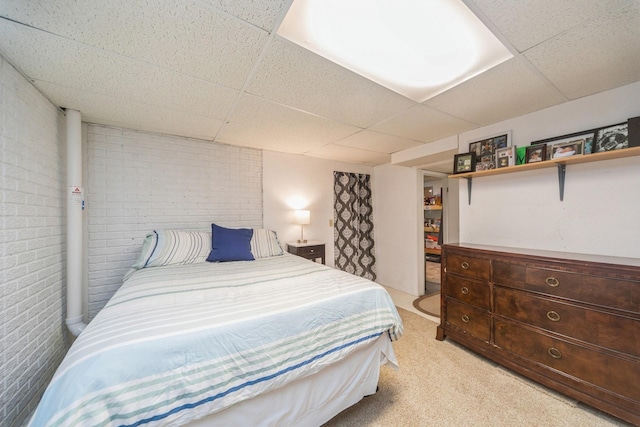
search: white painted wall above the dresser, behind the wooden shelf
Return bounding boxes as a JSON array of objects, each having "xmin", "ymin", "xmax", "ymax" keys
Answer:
[{"xmin": 458, "ymin": 83, "xmax": 640, "ymax": 258}]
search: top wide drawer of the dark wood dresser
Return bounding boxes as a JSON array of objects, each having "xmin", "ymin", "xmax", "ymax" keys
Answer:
[{"xmin": 493, "ymin": 261, "xmax": 640, "ymax": 313}]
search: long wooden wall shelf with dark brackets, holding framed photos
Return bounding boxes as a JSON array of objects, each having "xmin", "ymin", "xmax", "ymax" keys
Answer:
[{"xmin": 449, "ymin": 147, "xmax": 640, "ymax": 204}]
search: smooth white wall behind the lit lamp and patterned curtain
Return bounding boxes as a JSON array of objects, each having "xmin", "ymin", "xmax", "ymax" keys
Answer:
[{"xmin": 262, "ymin": 151, "xmax": 372, "ymax": 274}]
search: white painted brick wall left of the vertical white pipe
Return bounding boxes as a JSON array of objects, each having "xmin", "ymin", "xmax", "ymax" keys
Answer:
[{"xmin": 0, "ymin": 56, "xmax": 69, "ymax": 426}]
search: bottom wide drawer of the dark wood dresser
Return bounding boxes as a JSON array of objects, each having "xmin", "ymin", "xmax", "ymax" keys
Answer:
[{"xmin": 494, "ymin": 319, "xmax": 640, "ymax": 404}]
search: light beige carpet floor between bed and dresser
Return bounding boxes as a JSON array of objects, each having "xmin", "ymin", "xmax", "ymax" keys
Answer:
[{"xmin": 325, "ymin": 309, "xmax": 628, "ymax": 427}]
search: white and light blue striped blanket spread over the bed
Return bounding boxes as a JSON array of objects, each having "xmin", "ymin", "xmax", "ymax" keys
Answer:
[{"xmin": 31, "ymin": 254, "xmax": 402, "ymax": 427}]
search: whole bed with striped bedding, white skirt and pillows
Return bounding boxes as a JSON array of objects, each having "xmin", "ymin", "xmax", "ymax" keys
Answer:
[{"xmin": 30, "ymin": 228, "xmax": 402, "ymax": 426}]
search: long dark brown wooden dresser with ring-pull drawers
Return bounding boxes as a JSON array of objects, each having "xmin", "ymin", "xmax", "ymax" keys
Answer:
[{"xmin": 436, "ymin": 244, "xmax": 640, "ymax": 425}]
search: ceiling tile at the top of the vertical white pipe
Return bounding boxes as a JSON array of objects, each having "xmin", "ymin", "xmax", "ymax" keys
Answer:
[{"xmin": 34, "ymin": 81, "xmax": 222, "ymax": 140}]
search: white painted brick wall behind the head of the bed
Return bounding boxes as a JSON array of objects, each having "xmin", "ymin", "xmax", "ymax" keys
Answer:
[{"xmin": 85, "ymin": 124, "xmax": 262, "ymax": 319}]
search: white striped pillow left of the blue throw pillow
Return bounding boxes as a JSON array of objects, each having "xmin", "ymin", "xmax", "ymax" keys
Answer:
[{"xmin": 133, "ymin": 230, "xmax": 211, "ymax": 269}]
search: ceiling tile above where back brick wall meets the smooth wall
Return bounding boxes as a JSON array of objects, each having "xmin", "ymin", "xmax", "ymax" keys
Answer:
[{"xmin": 216, "ymin": 122, "xmax": 323, "ymax": 154}]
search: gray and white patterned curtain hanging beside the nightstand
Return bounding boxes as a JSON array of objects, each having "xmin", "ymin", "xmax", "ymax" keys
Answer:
[{"xmin": 333, "ymin": 172, "xmax": 376, "ymax": 280}]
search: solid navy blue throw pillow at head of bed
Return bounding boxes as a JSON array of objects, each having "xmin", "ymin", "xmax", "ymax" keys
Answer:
[{"xmin": 207, "ymin": 224, "xmax": 255, "ymax": 262}]
